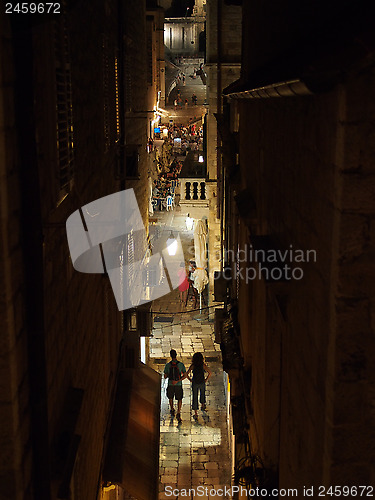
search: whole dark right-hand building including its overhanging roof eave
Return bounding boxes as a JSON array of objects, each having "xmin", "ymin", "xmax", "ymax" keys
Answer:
[{"xmin": 222, "ymin": 1, "xmax": 375, "ymax": 497}]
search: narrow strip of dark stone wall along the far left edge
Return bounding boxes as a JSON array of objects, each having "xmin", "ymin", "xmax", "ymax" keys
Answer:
[{"xmin": 0, "ymin": 13, "xmax": 32, "ymax": 500}]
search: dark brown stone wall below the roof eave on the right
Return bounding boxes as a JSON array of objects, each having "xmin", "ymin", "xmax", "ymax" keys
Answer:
[{"xmin": 234, "ymin": 60, "xmax": 375, "ymax": 489}]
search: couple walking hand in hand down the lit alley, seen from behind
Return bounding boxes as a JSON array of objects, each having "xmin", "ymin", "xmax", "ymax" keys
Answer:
[{"xmin": 164, "ymin": 349, "xmax": 211, "ymax": 423}]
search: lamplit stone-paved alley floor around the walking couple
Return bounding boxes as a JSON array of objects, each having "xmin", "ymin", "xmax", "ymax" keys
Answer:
[{"xmin": 149, "ymin": 211, "xmax": 231, "ymax": 500}]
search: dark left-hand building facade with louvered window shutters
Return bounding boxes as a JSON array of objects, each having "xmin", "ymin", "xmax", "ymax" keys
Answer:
[{"xmin": 0, "ymin": 0, "xmax": 157, "ymax": 500}]
